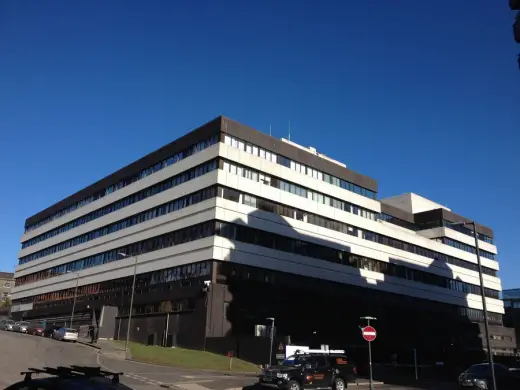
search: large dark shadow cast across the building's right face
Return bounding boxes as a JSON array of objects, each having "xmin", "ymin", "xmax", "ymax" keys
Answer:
[{"xmin": 206, "ymin": 206, "xmax": 484, "ymax": 383}]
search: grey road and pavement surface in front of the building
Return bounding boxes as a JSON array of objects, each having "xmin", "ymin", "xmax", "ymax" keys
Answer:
[{"xmin": 0, "ymin": 331, "xmax": 451, "ymax": 390}]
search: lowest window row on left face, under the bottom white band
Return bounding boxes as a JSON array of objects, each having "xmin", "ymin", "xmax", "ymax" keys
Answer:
[{"xmin": 21, "ymin": 260, "xmax": 209, "ymax": 303}]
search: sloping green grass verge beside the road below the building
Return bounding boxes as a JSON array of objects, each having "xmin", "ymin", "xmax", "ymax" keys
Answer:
[{"xmin": 122, "ymin": 343, "xmax": 260, "ymax": 373}]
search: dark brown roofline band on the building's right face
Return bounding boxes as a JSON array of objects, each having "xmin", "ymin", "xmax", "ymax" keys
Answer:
[{"xmin": 222, "ymin": 117, "xmax": 377, "ymax": 192}]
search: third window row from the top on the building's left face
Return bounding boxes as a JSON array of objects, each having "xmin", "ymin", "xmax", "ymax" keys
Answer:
[{"xmin": 20, "ymin": 187, "xmax": 216, "ymax": 264}]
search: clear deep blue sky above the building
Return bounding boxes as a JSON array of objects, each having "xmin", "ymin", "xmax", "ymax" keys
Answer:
[{"xmin": 0, "ymin": 0, "xmax": 520, "ymax": 287}]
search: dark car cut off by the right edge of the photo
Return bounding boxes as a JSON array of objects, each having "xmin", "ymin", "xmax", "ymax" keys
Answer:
[{"xmin": 459, "ymin": 363, "xmax": 520, "ymax": 390}]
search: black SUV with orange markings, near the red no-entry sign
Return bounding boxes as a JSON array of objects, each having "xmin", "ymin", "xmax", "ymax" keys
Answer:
[{"xmin": 259, "ymin": 353, "xmax": 357, "ymax": 390}]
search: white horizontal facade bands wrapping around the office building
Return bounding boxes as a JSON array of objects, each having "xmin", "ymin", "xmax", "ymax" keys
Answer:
[{"xmin": 12, "ymin": 134, "xmax": 504, "ymax": 314}]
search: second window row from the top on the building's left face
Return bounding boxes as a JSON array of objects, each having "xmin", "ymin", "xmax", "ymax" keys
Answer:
[{"xmin": 22, "ymin": 160, "xmax": 217, "ymax": 249}]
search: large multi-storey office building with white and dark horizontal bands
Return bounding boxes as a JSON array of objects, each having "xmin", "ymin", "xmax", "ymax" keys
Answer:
[{"xmin": 12, "ymin": 117, "xmax": 513, "ymax": 362}]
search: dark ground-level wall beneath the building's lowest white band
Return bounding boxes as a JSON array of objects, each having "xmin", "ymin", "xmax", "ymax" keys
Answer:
[{"xmin": 13, "ymin": 262, "xmax": 516, "ymax": 373}]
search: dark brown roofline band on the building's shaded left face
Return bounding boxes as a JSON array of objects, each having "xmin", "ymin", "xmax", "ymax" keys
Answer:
[{"xmin": 25, "ymin": 117, "xmax": 221, "ymax": 227}]
